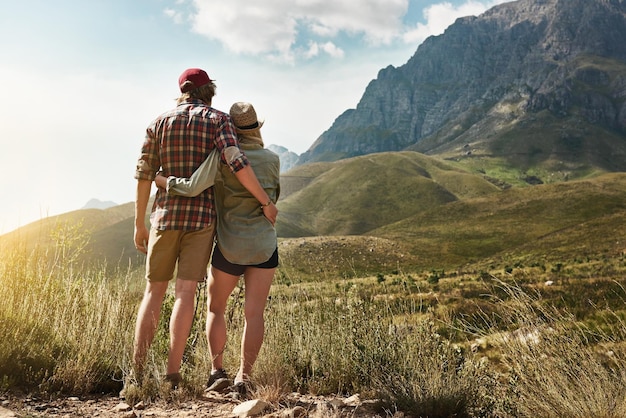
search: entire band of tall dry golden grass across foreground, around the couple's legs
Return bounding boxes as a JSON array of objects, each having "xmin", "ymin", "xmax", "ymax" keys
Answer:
[{"xmin": 0, "ymin": 230, "xmax": 626, "ymax": 417}]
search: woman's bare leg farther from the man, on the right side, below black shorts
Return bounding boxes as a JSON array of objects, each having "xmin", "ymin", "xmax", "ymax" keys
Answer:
[{"xmin": 235, "ymin": 267, "xmax": 276, "ymax": 382}]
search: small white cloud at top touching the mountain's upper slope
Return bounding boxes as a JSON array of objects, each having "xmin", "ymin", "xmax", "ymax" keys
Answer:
[{"xmin": 402, "ymin": 0, "xmax": 508, "ymax": 44}]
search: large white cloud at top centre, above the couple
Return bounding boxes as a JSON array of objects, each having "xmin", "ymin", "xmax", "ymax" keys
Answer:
[{"xmin": 166, "ymin": 0, "xmax": 409, "ymax": 62}]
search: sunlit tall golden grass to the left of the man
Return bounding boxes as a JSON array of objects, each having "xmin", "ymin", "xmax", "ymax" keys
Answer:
[{"xmin": 0, "ymin": 225, "xmax": 136, "ymax": 392}]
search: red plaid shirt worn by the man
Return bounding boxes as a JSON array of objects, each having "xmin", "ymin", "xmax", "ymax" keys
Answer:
[{"xmin": 135, "ymin": 99, "xmax": 249, "ymax": 230}]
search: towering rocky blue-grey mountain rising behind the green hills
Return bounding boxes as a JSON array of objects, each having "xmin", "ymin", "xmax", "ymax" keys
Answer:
[{"xmin": 298, "ymin": 0, "xmax": 626, "ymax": 181}]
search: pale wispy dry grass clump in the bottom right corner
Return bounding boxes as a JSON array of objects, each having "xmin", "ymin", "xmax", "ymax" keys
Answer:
[{"xmin": 470, "ymin": 284, "xmax": 626, "ymax": 418}]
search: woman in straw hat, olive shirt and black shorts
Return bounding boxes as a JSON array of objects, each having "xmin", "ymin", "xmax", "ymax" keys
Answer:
[{"xmin": 157, "ymin": 102, "xmax": 280, "ymax": 397}]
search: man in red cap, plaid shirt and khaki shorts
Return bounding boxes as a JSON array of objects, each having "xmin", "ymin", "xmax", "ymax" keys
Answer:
[{"xmin": 133, "ymin": 68, "xmax": 278, "ymax": 387}]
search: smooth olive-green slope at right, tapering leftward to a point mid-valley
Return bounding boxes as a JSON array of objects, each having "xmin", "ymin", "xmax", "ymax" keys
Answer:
[{"xmin": 371, "ymin": 174, "xmax": 626, "ymax": 268}]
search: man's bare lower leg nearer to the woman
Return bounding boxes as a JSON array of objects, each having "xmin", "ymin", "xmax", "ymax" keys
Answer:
[{"xmin": 167, "ymin": 279, "xmax": 198, "ymax": 375}]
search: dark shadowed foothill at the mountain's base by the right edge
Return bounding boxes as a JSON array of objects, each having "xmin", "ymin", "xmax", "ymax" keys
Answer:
[{"xmin": 440, "ymin": 112, "xmax": 626, "ymax": 186}]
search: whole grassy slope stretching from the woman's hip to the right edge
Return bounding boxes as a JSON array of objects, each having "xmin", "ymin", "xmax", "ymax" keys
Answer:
[{"xmin": 280, "ymin": 174, "xmax": 626, "ymax": 280}]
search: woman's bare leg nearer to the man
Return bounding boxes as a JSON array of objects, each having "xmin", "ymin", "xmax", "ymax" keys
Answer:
[{"xmin": 206, "ymin": 266, "xmax": 239, "ymax": 370}]
